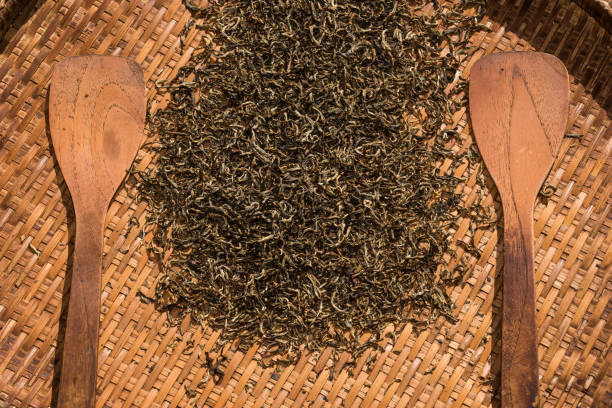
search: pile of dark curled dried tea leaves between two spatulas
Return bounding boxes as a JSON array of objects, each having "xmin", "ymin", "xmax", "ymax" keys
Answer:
[{"xmin": 137, "ymin": 0, "xmax": 484, "ymax": 359}]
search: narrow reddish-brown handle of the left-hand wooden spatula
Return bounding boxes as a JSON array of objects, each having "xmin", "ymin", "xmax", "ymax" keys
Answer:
[{"xmin": 57, "ymin": 211, "xmax": 104, "ymax": 408}]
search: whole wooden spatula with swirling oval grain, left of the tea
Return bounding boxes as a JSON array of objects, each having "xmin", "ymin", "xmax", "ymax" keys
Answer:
[{"xmin": 49, "ymin": 56, "xmax": 145, "ymax": 408}]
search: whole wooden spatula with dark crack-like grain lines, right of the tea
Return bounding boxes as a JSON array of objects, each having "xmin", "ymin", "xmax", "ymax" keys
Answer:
[{"xmin": 470, "ymin": 52, "xmax": 569, "ymax": 408}]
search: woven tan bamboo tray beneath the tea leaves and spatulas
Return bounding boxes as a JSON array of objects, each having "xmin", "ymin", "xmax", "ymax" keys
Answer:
[{"xmin": 0, "ymin": 0, "xmax": 612, "ymax": 408}]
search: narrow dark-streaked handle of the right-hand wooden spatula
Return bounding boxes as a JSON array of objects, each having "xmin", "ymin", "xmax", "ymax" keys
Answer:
[{"xmin": 501, "ymin": 205, "xmax": 538, "ymax": 408}]
